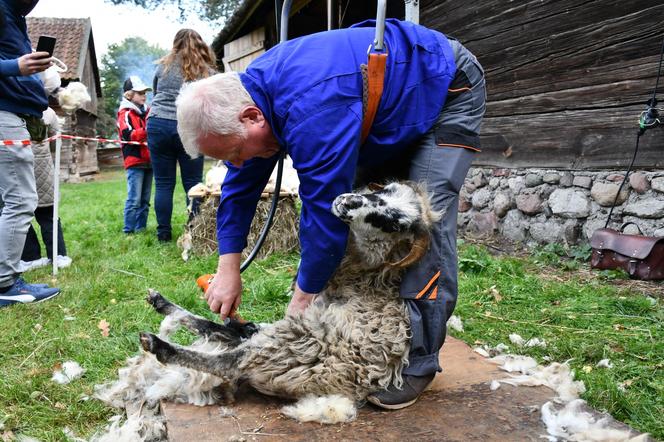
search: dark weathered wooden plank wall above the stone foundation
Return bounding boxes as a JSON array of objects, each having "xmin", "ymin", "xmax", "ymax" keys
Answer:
[{"xmin": 420, "ymin": 0, "xmax": 664, "ymax": 169}]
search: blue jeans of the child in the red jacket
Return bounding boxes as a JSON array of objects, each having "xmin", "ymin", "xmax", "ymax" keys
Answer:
[{"xmin": 123, "ymin": 167, "xmax": 152, "ymax": 233}]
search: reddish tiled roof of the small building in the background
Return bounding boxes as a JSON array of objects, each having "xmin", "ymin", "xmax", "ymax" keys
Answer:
[{"xmin": 27, "ymin": 17, "xmax": 101, "ymax": 95}]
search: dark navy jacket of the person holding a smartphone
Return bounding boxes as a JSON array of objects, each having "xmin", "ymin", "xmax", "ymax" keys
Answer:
[{"xmin": 0, "ymin": 0, "xmax": 48, "ymax": 117}]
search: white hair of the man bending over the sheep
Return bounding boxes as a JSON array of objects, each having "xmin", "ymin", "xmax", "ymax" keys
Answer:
[{"xmin": 175, "ymin": 72, "xmax": 255, "ymax": 158}]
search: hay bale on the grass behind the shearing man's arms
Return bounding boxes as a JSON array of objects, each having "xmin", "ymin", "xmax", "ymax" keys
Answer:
[{"xmin": 178, "ymin": 194, "xmax": 300, "ymax": 261}]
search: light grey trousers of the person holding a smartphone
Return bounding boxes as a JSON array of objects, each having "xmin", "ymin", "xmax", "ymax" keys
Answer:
[{"xmin": 0, "ymin": 111, "xmax": 37, "ymax": 287}]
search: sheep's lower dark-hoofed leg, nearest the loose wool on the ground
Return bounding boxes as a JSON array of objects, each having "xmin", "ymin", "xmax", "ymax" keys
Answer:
[{"xmin": 140, "ymin": 332, "xmax": 246, "ymax": 379}]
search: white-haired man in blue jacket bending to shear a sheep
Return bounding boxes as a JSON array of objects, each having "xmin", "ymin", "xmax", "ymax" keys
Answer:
[{"xmin": 177, "ymin": 19, "xmax": 486, "ymax": 409}]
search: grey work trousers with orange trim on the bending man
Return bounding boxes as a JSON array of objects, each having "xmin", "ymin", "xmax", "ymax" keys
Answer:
[{"xmin": 356, "ymin": 40, "xmax": 486, "ymax": 376}]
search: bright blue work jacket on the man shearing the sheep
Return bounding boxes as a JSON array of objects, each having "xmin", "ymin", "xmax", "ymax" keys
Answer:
[{"xmin": 217, "ymin": 19, "xmax": 456, "ymax": 293}]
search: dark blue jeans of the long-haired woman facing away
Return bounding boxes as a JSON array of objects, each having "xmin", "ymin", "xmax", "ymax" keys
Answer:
[{"xmin": 147, "ymin": 117, "xmax": 204, "ymax": 240}]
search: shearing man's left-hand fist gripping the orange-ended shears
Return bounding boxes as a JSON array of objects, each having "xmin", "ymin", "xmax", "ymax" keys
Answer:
[{"xmin": 205, "ymin": 253, "xmax": 242, "ymax": 321}]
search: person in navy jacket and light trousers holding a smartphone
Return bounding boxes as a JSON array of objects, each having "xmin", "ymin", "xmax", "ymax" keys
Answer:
[{"xmin": 0, "ymin": 0, "xmax": 60, "ymax": 307}]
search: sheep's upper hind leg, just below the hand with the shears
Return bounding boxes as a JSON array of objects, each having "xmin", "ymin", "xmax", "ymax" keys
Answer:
[{"xmin": 146, "ymin": 289, "xmax": 258, "ymax": 345}]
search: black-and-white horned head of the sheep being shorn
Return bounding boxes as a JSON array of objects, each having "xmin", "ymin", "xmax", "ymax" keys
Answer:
[{"xmin": 332, "ymin": 182, "xmax": 439, "ymax": 268}]
